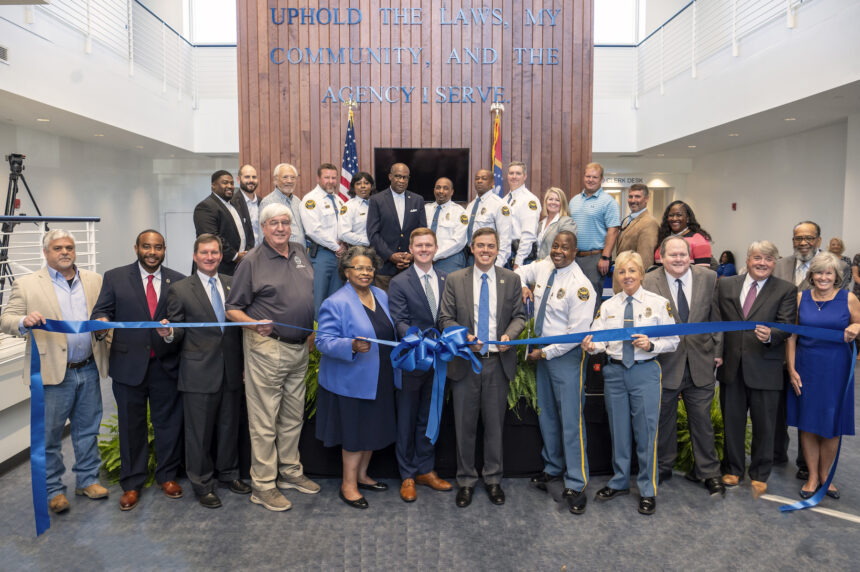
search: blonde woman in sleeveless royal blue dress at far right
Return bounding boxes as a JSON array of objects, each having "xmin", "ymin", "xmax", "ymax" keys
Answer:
[{"xmin": 786, "ymin": 252, "xmax": 860, "ymax": 499}]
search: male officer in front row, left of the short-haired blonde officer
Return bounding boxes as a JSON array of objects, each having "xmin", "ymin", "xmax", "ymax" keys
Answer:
[{"xmin": 516, "ymin": 230, "xmax": 597, "ymax": 514}]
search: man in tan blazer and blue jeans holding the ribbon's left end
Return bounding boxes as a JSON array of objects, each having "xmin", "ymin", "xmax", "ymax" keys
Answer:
[{"xmin": 0, "ymin": 229, "xmax": 108, "ymax": 513}]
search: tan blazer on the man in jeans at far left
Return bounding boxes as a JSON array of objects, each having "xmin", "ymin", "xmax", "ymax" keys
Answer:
[{"xmin": 0, "ymin": 267, "xmax": 108, "ymax": 385}]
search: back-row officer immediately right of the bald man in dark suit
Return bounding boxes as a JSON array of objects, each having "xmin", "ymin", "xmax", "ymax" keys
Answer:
[{"xmin": 424, "ymin": 177, "xmax": 469, "ymax": 274}]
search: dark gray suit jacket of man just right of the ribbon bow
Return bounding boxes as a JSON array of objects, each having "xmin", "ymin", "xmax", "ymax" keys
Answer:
[{"xmin": 438, "ymin": 266, "xmax": 526, "ymax": 380}]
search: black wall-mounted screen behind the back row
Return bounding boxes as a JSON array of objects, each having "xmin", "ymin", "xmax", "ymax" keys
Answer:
[{"xmin": 373, "ymin": 147, "xmax": 471, "ymax": 203}]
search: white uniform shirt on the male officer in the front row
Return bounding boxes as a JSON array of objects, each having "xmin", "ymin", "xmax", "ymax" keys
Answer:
[{"xmin": 515, "ymin": 258, "xmax": 597, "ymax": 360}]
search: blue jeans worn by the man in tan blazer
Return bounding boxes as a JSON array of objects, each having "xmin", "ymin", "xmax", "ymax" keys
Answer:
[{"xmin": 45, "ymin": 361, "xmax": 102, "ymax": 499}]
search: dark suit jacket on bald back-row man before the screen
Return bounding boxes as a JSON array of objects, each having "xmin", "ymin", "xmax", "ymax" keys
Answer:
[{"xmin": 367, "ymin": 187, "xmax": 427, "ymax": 276}]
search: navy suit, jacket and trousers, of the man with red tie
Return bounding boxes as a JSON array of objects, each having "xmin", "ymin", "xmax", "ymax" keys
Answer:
[{"xmin": 92, "ymin": 262, "xmax": 185, "ymax": 491}]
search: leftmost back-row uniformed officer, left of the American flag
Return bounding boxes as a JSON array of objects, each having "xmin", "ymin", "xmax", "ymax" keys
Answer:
[{"xmin": 301, "ymin": 163, "xmax": 346, "ymax": 318}]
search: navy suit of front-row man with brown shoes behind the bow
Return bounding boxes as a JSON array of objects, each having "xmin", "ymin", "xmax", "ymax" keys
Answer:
[{"xmin": 388, "ymin": 266, "xmax": 445, "ymax": 480}]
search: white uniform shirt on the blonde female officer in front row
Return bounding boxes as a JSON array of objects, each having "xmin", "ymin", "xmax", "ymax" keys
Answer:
[{"xmin": 591, "ymin": 286, "xmax": 681, "ymax": 361}]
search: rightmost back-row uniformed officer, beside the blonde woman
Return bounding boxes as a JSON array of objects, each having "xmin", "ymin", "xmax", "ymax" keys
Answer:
[{"xmin": 505, "ymin": 161, "xmax": 540, "ymax": 269}]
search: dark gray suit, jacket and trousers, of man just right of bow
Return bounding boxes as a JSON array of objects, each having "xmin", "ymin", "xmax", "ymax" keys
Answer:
[{"xmin": 438, "ymin": 266, "xmax": 526, "ymax": 487}]
